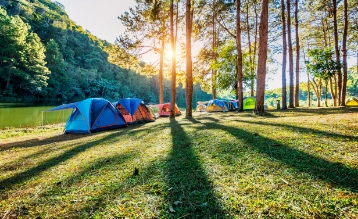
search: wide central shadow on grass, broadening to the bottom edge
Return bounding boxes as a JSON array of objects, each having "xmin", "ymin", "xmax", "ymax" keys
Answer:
[{"xmin": 166, "ymin": 120, "xmax": 225, "ymax": 218}]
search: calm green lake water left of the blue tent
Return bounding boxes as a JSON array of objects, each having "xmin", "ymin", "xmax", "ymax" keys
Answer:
[{"xmin": 0, "ymin": 103, "xmax": 71, "ymax": 129}]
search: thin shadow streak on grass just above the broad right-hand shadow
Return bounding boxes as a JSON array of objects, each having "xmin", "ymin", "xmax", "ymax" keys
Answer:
[{"xmin": 234, "ymin": 120, "xmax": 358, "ymax": 141}]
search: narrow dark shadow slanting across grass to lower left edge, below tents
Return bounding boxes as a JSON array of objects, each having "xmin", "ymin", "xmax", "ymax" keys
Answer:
[{"xmin": 0, "ymin": 130, "xmax": 118, "ymax": 194}]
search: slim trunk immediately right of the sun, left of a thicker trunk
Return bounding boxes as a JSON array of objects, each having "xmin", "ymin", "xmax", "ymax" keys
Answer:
[{"xmin": 170, "ymin": 0, "xmax": 176, "ymax": 118}]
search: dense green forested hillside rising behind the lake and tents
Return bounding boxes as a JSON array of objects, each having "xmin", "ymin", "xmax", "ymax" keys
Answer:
[{"xmin": 0, "ymin": 0, "xmax": 211, "ymax": 107}]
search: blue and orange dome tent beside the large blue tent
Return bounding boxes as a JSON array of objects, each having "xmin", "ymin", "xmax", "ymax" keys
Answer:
[{"xmin": 115, "ymin": 98, "xmax": 155, "ymax": 124}]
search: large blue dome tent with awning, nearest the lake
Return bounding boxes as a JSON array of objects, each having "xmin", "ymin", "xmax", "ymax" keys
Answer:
[{"xmin": 48, "ymin": 98, "xmax": 127, "ymax": 133}]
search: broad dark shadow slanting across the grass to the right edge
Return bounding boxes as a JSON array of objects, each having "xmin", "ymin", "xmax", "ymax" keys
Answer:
[{"xmin": 196, "ymin": 123, "xmax": 358, "ymax": 193}]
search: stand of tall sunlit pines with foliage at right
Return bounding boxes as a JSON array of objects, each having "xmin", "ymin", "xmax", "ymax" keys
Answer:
[{"xmin": 117, "ymin": 0, "xmax": 358, "ymax": 117}]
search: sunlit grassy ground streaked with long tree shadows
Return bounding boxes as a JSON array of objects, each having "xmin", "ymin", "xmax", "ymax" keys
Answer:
[{"xmin": 0, "ymin": 108, "xmax": 358, "ymax": 218}]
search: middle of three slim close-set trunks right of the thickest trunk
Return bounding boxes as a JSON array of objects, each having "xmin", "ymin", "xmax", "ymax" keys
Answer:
[{"xmin": 287, "ymin": 0, "xmax": 295, "ymax": 108}]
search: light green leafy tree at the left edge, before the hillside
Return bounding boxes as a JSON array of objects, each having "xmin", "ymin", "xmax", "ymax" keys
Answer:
[{"xmin": 0, "ymin": 7, "xmax": 50, "ymax": 96}]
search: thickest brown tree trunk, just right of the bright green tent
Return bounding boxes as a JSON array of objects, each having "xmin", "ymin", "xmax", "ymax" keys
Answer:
[{"xmin": 255, "ymin": 0, "xmax": 268, "ymax": 114}]
